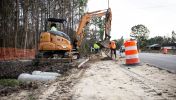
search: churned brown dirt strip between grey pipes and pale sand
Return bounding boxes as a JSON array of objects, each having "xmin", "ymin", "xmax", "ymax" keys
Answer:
[{"xmin": 0, "ymin": 61, "xmax": 85, "ymax": 100}]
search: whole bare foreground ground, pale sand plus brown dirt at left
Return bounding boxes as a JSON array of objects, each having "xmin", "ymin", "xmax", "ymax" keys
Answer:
[{"xmin": 0, "ymin": 54, "xmax": 176, "ymax": 100}]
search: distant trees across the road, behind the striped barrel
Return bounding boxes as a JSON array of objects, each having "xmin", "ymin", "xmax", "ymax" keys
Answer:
[{"xmin": 115, "ymin": 24, "xmax": 176, "ymax": 50}]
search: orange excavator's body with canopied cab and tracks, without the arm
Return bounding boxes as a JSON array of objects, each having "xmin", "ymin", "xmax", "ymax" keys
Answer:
[{"xmin": 37, "ymin": 18, "xmax": 72, "ymax": 58}]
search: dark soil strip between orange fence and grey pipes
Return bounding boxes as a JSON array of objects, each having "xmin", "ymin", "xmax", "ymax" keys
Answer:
[{"xmin": 0, "ymin": 60, "xmax": 72, "ymax": 79}]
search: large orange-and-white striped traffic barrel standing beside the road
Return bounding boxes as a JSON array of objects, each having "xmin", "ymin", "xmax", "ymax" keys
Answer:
[{"xmin": 124, "ymin": 40, "xmax": 140, "ymax": 65}]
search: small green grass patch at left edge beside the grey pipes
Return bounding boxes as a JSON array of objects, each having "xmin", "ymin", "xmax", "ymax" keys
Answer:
[{"xmin": 0, "ymin": 79, "xmax": 21, "ymax": 87}]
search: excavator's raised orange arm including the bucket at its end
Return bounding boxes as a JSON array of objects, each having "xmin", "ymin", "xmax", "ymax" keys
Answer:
[{"xmin": 76, "ymin": 8, "xmax": 112, "ymax": 56}]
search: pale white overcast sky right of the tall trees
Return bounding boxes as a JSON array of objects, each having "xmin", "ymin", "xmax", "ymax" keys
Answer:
[{"xmin": 87, "ymin": 0, "xmax": 176, "ymax": 39}]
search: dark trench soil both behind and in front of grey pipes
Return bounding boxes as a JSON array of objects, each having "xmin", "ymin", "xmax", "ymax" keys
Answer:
[{"xmin": 0, "ymin": 60, "xmax": 82, "ymax": 96}]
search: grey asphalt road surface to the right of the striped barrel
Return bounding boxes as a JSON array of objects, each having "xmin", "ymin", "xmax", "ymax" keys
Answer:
[{"xmin": 139, "ymin": 53, "xmax": 176, "ymax": 73}]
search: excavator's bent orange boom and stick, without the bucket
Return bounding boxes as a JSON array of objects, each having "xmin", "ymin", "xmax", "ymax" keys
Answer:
[{"xmin": 76, "ymin": 8, "xmax": 112, "ymax": 47}]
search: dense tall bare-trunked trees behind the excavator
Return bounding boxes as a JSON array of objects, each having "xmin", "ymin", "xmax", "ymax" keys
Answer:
[{"xmin": 0, "ymin": 0, "xmax": 88, "ymax": 49}]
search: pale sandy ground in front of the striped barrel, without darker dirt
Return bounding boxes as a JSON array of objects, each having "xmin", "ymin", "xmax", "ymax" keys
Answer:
[{"xmin": 72, "ymin": 57, "xmax": 176, "ymax": 100}]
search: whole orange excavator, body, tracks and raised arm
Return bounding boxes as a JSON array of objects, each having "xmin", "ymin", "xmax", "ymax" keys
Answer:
[{"xmin": 36, "ymin": 8, "xmax": 112, "ymax": 62}]
